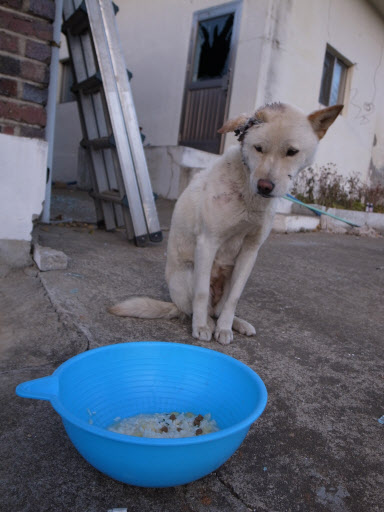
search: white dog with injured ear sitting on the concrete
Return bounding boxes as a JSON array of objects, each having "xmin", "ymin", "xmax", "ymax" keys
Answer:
[{"xmin": 109, "ymin": 103, "xmax": 342, "ymax": 345}]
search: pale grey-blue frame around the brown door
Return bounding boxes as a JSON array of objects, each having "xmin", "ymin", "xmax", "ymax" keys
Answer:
[{"xmin": 178, "ymin": 0, "xmax": 243, "ymax": 154}]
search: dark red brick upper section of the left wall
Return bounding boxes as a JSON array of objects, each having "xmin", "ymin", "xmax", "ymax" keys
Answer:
[{"xmin": 0, "ymin": 0, "xmax": 55, "ymax": 138}]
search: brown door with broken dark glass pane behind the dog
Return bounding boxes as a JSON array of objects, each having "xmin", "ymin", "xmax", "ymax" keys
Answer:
[{"xmin": 179, "ymin": 2, "xmax": 241, "ymax": 153}]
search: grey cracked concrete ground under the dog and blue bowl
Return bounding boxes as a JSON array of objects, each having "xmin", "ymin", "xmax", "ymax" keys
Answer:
[{"xmin": 0, "ymin": 192, "xmax": 384, "ymax": 512}]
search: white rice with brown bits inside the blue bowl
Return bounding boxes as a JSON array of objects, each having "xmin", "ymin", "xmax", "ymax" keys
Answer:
[{"xmin": 107, "ymin": 412, "xmax": 219, "ymax": 438}]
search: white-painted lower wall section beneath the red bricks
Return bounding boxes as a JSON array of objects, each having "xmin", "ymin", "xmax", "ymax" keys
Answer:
[{"xmin": 0, "ymin": 134, "xmax": 48, "ymax": 241}]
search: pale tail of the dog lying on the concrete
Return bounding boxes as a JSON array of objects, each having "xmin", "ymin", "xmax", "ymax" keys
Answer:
[{"xmin": 108, "ymin": 297, "xmax": 185, "ymax": 319}]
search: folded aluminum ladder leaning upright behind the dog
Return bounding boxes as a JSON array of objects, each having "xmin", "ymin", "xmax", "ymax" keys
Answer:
[{"xmin": 62, "ymin": 0, "xmax": 163, "ymax": 246}]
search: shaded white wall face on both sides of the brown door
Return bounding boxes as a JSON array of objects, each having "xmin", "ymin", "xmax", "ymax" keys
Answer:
[{"xmin": 115, "ymin": 0, "xmax": 268, "ymax": 146}]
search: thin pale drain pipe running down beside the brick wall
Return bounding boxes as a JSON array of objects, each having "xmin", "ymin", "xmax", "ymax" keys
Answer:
[{"xmin": 41, "ymin": 0, "xmax": 63, "ymax": 224}]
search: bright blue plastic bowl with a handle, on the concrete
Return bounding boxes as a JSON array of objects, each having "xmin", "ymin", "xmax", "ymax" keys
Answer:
[{"xmin": 16, "ymin": 342, "xmax": 267, "ymax": 487}]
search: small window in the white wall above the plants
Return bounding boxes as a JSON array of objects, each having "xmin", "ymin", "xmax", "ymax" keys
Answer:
[{"xmin": 319, "ymin": 46, "xmax": 349, "ymax": 106}]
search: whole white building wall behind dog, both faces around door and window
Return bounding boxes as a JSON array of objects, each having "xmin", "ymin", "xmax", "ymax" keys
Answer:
[{"xmin": 54, "ymin": 0, "xmax": 384, "ymax": 190}]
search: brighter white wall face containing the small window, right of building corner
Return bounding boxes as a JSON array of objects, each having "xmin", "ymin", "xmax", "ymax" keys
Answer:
[{"xmin": 258, "ymin": 0, "xmax": 384, "ymax": 181}]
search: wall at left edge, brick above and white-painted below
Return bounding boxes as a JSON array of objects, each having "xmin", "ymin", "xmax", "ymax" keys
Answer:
[{"xmin": 0, "ymin": 0, "xmax": 55, "ymax": 263}]
